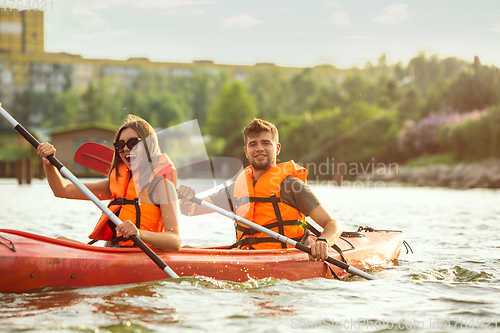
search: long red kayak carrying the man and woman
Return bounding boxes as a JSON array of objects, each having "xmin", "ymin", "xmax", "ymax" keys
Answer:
[{"xmin": 0, "ymin": 229, "xmax": 404, "ymax": 292}]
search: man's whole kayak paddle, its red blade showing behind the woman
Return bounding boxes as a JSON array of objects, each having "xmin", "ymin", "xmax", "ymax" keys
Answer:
[{"xmin": 75, "ymin": 142, "xmax": 377, "ymax": 280}]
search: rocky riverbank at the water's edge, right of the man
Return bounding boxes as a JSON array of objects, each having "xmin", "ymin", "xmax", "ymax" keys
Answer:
[{"xmin": 356, "ymin": 159, "xmax": 500, "ymax": 189}]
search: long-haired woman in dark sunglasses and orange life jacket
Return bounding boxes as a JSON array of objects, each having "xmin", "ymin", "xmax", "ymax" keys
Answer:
[{"xmin": 37, "ymin": 115, "xmax": 181, "ymax": 251}]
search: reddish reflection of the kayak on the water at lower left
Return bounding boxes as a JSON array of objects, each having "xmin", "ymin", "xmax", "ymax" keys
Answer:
[{"xmin": 0, "ymin": 283, "xmax": 179, "ymax": 330}]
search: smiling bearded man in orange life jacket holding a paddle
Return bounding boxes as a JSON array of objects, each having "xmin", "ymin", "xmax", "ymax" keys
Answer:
[{"xmin": 178, "ymin": 119, "xmax": 342, "ymax": 261}]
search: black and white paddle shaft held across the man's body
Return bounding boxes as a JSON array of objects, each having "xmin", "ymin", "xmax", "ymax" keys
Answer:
[{"xmin": 191, "ymin": 197, "xmax": 377, "ymax": 280}]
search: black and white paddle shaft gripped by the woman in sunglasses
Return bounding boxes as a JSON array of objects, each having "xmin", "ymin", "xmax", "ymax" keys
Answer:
[{"xmin": 0, "ymin": 106, "xmax": 179, "ymax": 278}]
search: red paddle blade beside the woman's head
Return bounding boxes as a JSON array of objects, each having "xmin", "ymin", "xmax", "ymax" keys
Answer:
[{"xmin": 75, "ymin": 142, "xmax": 114, "ymax": 176}]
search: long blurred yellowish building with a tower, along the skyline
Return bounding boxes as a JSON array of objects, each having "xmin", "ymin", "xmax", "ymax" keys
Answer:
[{"xmin": 0, "ymin": 10, "xmax": 341, "ymax": 105}]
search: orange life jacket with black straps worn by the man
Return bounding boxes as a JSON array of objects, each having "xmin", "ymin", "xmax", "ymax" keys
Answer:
[{"xmin": 233, "ymin": 161, "xmax": 307, "ymax": 249}]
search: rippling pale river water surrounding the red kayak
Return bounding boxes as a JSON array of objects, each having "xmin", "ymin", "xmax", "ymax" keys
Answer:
[{"xmin": 0, "ymin": 179, "xmax": 500, "ymax": 332}]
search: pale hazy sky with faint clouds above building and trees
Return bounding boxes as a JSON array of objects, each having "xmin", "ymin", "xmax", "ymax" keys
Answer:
[{"xmin": 45, "ymin": 0, "xmax": 500, "ymax": 68}]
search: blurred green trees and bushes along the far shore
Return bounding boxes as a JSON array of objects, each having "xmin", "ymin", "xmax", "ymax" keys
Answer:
[{"xmin": 0, "ymin": 51, "xmax": 500, "ymax": 183}]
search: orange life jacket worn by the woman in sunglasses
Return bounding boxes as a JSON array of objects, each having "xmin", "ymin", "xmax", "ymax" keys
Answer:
[{"xmin": 89, "ymin": 155, "xmax": 177, "ymax": 246}]
